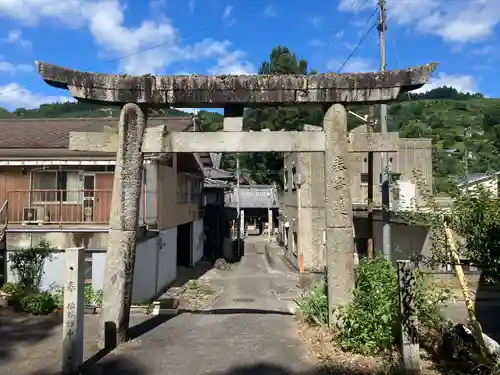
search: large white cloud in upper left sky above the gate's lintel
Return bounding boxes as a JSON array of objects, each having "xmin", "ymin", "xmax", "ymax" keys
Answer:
[{"xmin": 0, "ymin": 0, "xmax": 251, "ymax": 75}]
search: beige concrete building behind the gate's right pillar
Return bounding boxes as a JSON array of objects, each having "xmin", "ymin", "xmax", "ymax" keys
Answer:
[{"xmin": 284, "ymin": 127, "xmax": 432, "ymax": 272}]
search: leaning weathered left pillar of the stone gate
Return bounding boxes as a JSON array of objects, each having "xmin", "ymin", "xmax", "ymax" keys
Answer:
[{"xmin": 101, "ymin": 103, "xmax": 147, "ymax": 347}]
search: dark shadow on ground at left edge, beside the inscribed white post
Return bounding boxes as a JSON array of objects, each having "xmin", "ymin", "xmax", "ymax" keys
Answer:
[{"xmin": 0, "ymin": 307, "xmax": 61, "ymax": 367}]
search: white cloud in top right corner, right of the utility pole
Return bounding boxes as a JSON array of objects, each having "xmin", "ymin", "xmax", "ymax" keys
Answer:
[{"xmin": 339, "ymin": 0, "xmax": 500, "ymax": 43}]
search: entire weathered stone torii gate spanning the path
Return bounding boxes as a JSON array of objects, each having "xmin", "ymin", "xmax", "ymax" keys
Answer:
[{"xmin": 36, "ymin": 62, "xmax": 437, "ymax": 341}]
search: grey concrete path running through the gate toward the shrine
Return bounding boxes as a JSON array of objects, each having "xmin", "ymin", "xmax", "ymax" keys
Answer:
[{"xmin": 85, "ymin": 238, "xmax": 322, "ymax": 375}]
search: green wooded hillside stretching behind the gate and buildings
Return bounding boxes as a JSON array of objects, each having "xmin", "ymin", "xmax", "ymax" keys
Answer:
[{"xmin": 0, "ymin": 87, "xmax": 500, "ymax": 191}]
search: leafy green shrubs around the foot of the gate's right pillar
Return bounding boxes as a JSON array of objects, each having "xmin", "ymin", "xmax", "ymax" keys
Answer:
[{"xmin": 297, "ymin": 259, "xmax": 451, "ymax": 355}]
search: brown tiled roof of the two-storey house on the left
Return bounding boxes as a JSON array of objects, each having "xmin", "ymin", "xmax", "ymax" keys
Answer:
[{"xmin": 0, "ymin": 117, "xmax": 192, "ymax": 149}]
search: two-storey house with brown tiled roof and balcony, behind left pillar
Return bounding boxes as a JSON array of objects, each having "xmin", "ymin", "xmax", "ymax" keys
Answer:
[{"xmin": 0, "ymin": 117, "xmax": 212, "ymax": 302}]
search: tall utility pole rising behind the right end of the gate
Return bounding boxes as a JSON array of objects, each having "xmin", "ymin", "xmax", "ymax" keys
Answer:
[{"xmin": 378, "ymin": 0, "xmax": 391, "ymax": 260}]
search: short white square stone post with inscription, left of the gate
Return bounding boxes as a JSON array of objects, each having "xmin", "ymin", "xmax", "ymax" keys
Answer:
[{"xmin": 62, "ymin": 247, "xmax": 85, "ymax": 374}]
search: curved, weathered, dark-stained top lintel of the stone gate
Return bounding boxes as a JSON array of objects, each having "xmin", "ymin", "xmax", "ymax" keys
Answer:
[{"xmin": 36, "ymin": 61, "xmax": 437, "ymax": 108}]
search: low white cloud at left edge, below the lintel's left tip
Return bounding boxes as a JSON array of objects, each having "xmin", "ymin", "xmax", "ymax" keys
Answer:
[{"xmin": 0, "ymin": 83, "xmax": 74, "ymax": 110}]
